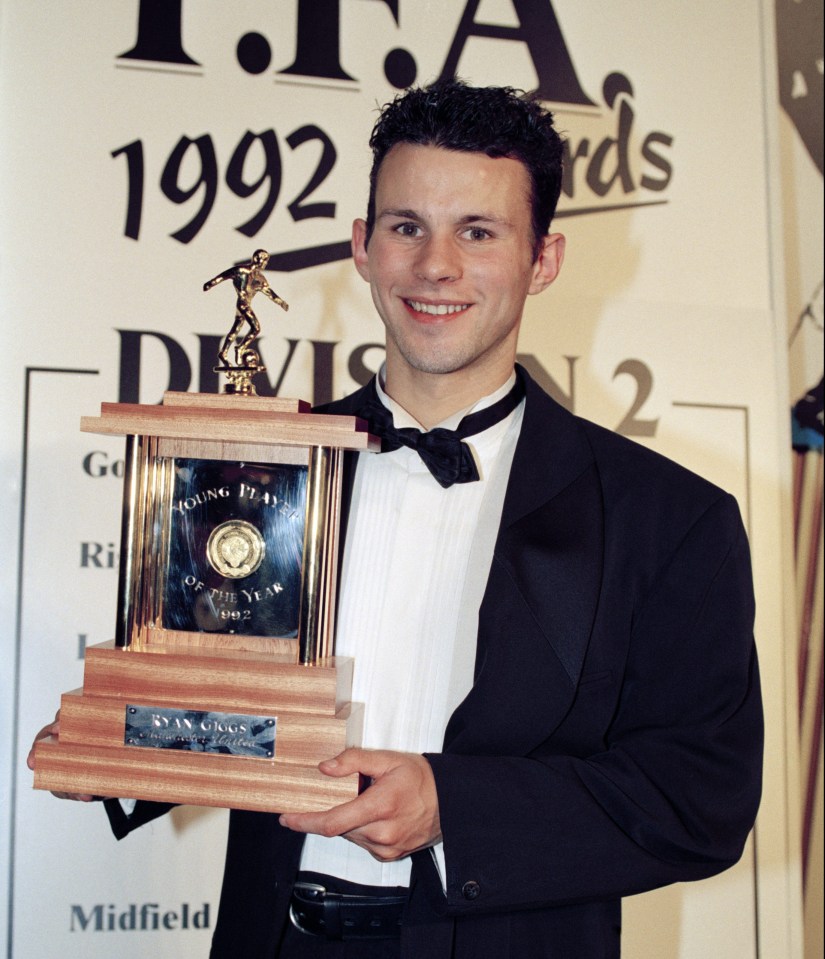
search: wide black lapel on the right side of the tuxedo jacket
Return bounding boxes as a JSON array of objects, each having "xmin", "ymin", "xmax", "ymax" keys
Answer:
[{"xmin": 445, "ymin": 378, "xmax": 603, "ymax": 755}]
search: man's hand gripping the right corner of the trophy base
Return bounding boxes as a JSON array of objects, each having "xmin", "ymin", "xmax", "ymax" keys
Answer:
[{"xmin": 280, "ymin": 749, "xmax": 441, "ymax": 862}]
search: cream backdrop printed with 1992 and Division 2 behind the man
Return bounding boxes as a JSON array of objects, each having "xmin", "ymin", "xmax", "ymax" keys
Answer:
[{"xmin": 0, "ymin": 0, "xmax": 798, "ymax": 959}]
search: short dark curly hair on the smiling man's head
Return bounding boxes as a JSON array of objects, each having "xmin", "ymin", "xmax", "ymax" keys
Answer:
[{"xmin": 367, "ymin": 80, "xmax": 562, "ymax": 257}]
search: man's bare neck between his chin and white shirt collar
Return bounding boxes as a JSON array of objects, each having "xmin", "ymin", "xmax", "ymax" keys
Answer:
[{"xmin": 384, "ymin": 361, "xmax": 513, "ymax": 430}]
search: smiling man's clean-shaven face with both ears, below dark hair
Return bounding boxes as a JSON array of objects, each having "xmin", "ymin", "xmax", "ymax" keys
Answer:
[{"xmin": 353, "ymin": 144, "xmax": 564, "ymax": 389}]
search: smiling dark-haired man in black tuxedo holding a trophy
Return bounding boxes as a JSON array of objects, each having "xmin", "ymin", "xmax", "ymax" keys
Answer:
[{"xmin": 29, "ymin": 81, "xmax": 762, "ymax": 959}]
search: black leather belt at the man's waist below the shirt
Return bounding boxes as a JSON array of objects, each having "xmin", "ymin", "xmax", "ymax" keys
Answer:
[{"xmin": 289, "ymin": 881, "xmax": 407, "ymax": 939}]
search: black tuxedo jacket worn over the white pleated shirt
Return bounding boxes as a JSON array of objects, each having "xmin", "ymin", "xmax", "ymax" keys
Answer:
[{"xmin": 110, "ymin": 370, "xmax": 762, "ymax": 959}]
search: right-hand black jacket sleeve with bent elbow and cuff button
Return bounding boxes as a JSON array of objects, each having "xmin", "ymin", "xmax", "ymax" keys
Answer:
[{"xmin": 427, "ymin": 496, "xmax": 763, "ymax": 915}]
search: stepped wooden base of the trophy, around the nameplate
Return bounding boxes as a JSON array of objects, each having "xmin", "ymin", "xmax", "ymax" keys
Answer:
[{"xmin": 34, "ymin": 641, "xmax": 363, "ymax": 813}]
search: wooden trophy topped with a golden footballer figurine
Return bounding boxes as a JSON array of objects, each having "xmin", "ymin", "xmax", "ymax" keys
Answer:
[{"xmin": 34, "ymin": 250, "xmax": 380, "ymax": 812}]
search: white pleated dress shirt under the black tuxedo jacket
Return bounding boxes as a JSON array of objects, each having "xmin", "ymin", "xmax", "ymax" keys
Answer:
[{"xmin": 301, "ymin": 374, "xmax": 524, "ymax": 886}]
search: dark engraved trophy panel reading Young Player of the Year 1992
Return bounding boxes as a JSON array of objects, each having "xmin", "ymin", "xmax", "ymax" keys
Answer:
[{"xmin": 156, "ymin": 459, "xmax": 307, "ymax": 638}]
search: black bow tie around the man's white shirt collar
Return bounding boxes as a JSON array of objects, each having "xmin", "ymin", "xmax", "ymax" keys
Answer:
[{"xmin": 357, "ymin": 369, "xmax": 524, "ymax": 489}]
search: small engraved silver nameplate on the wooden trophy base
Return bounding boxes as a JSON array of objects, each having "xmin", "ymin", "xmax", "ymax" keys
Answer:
[{"xmin": 123, "ymin": 704, "xmax": 277, "ymax": 759}]
